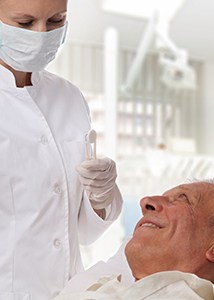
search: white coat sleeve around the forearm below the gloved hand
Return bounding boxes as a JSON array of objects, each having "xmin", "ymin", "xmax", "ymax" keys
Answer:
[{"xmin": 78, "ymin": 186, "xmax": 122, "ymax": 245}]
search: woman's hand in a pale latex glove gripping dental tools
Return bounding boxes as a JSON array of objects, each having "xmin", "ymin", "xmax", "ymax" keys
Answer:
[{"xmin": 77, "ymin": 157, "xmax": 117, "ymax": 209}]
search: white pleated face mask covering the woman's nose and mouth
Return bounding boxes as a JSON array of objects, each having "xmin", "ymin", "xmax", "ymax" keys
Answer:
[{"xmin": 0, "ymin": 21, "xmax": 67, "ymax": 72}]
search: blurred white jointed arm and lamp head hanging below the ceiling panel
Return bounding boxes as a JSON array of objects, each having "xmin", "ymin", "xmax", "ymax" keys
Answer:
[{"xmin": 122, "ymin": 12, "xmax": 196, "ymax": 92}]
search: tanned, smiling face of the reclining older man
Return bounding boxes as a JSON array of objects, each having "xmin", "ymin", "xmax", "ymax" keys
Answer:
[{"xmin": 126, "ymin": 182, "xmax": 214, "ymax": 279}]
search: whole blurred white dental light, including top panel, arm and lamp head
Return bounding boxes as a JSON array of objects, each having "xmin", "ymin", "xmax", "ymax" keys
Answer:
[{"xmin": 102, "ymin": 0, "xmax": 196, "ymax": 92}]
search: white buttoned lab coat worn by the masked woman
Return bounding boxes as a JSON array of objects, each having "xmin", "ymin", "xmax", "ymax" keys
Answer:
[{"xmin": 0, "ymin": 66, "xmax": 121, "ymax": 300}]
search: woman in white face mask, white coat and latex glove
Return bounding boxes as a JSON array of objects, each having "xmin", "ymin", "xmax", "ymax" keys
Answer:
[{"xmin": 0, "ymin": 0, "xmax": 122, "ymax": 300}]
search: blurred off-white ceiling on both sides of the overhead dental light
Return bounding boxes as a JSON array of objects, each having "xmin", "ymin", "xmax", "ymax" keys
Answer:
[{"xmin": 69, "ymin": 0, "xmax": 214, "ymax": 61}]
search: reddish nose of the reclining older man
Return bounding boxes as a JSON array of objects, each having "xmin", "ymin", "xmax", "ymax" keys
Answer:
[{"xmin": 140, "ymin": 196, "xmax": 167, "ymax": 214}]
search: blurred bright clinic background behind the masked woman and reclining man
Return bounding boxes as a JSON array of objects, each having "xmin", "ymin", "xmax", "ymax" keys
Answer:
[{"xmin": 48, "ymin": 0, "xmax": 214, "ymax": 267}]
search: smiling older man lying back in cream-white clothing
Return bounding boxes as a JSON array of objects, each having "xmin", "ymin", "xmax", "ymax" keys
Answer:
[{"xmin": 53, "ymin": 181, "xmax": 214, "ymax": 300}]
